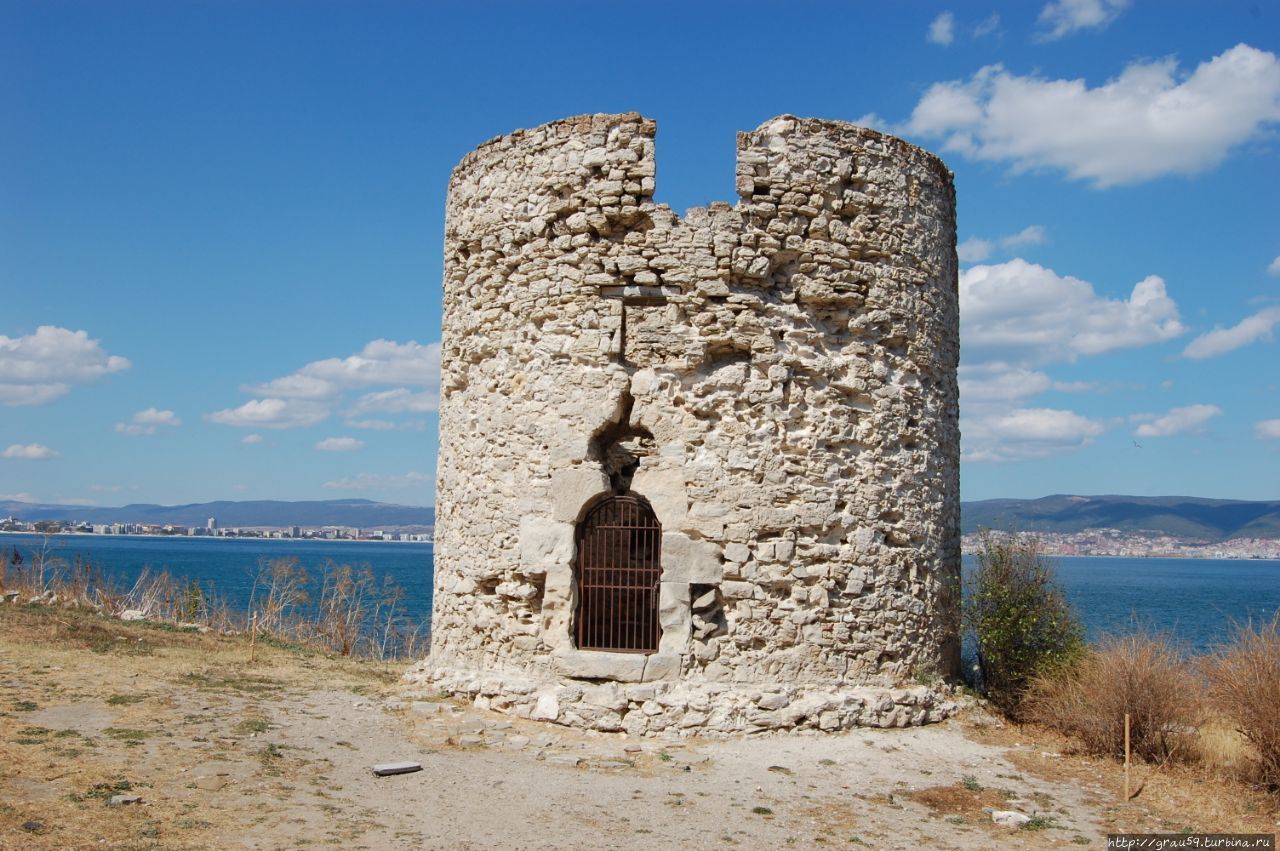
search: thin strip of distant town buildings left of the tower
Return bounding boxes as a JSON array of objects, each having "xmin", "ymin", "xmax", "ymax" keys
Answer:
[{"xmin": 0, "ymin": 517, "xmax": 435, "ymax": 544}]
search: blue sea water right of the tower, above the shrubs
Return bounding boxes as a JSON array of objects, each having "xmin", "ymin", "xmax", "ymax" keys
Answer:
[{"xmin": 964, "ymin": 555, "xmax": 1280, "ymax": 651}]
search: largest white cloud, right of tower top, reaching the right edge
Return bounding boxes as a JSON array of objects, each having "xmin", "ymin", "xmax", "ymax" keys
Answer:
[{"xmin": 900, "ymin": 44, "xmax": 1280, "ymax": 188}]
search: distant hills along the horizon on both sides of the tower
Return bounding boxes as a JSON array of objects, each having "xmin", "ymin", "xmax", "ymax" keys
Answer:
[{"xmin": 0, "ymin": 494, "xmax": 1280, "ymax": 541}]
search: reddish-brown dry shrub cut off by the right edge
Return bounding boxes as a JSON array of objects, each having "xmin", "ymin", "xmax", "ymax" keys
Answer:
[{"xmin": 1204, "ymin": 613, "xmax": 1280, "ymax": 788}]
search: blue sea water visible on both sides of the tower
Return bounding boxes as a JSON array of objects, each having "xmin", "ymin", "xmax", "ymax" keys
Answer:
[{"xmin": 0, "ymin": 535, "xmax": 1280, "ymax": 653}]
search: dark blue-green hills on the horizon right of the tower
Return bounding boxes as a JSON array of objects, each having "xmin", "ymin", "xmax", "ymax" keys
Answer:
[{"xmin": 960, "ymin": 494, "xmax": 1280, "ymax": 541}]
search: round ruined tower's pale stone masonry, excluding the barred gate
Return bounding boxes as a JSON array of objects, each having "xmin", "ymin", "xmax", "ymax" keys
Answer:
[{"xmin": 416, "ymin": 114, "xmax": 960, "ymax": 733}]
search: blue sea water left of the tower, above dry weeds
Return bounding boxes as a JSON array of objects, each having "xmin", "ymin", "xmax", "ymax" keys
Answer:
[{"xmin": 0, "ymin": 535, "xmax": 431, "ymax": 621}]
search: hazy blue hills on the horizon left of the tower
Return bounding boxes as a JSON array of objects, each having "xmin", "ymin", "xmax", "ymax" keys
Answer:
[{"xmin": 0, "ymin": 499, "xmax": 435, "ymax": 529}]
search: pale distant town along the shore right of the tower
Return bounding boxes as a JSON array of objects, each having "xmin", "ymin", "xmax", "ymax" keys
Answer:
[{"xmin": 960, "ymin": 529, "xmax": 1280, "ymax": 559}]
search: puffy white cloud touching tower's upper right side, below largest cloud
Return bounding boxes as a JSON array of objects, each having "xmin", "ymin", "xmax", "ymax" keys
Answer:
[{"xmin": 960, "ymin": 258, "xmax": 1185, "ymax": 366}]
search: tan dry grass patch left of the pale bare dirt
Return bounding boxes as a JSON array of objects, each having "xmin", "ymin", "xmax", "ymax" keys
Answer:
[{"xmin": 0, "ymin": 604, "xmax": 399, "ymax": 848}]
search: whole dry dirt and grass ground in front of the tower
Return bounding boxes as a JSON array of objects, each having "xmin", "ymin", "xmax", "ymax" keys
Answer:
[{"xmin": 0, "ymin": 605, "xmax": 1280, "ymax": 848}]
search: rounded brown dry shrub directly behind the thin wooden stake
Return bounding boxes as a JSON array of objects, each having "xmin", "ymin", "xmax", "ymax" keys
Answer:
[{"xmin": 1024, "ymin": 631, "xmax": 1203, "ymax": 761}]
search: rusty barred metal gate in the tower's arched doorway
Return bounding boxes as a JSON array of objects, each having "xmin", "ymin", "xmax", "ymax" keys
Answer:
[{"xmin": 576, "ymin": 497, "xmax": 662, "ymax": 653}]
